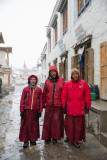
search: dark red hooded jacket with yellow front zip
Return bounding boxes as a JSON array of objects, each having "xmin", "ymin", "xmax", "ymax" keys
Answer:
[{"xmin": 20, "ymin": 76, "xmax": 43, "ymax": 112}]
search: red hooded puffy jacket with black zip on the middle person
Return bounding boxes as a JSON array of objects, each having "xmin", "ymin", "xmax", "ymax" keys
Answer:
[{"xmin": 43, "ymin": 66, "xmax": 64, "ymax": 108}]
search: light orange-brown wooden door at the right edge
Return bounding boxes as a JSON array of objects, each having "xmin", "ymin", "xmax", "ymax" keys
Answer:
[{"xmin": 100, "ymin": 42, "xmax": 107, "ymax": 100}]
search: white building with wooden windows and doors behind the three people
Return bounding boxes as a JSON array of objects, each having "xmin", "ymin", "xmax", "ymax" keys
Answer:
[{"xmin": 43, "ymin": 0, "xmax": 107, "ymax": 100}]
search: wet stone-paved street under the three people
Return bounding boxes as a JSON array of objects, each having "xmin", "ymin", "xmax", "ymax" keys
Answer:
[{"xmin": 0, "ymin": 85, "xmax": 107, "ymax": 160}]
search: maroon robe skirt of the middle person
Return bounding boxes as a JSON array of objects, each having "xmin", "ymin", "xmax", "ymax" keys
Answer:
[{"xmin": 42, "ymin": 106, "xmax": 64, "ymax": 140}]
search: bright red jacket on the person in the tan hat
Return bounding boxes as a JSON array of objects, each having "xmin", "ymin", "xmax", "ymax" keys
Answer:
[{"xmin": 61, "ymin": 79, "xmax": 91, "ymax": 116}]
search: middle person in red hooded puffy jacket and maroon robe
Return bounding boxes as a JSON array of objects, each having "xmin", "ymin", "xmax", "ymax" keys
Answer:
[{"xmin": 42, "ymin": 66, "xmax": 64, "ymax": 143}]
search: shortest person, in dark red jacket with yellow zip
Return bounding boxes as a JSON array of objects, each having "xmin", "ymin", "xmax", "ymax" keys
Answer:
[{"xmin": 19, "ymin": 75, "xmax": 42, "ymax": 148}]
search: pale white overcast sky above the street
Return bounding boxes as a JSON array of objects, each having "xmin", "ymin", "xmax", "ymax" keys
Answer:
[{"xmin": 0, "ymin": 0, "xmax": 56, "ymax": 68}]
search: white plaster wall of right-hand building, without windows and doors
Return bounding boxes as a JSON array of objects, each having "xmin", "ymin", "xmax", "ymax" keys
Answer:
[{"xmin": 46, "ymin": 0, "xmax": 107, "ymax": 89}]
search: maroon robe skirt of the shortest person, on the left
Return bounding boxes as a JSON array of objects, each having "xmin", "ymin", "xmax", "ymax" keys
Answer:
[{"xmin": 19, "ymin": 109, "xmax": 40, "ymax": 142}]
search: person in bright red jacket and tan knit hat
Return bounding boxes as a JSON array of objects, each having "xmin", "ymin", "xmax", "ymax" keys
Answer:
[{"xmin": 61, "ymin": 68, "xmax": 91, "ymax": 148}]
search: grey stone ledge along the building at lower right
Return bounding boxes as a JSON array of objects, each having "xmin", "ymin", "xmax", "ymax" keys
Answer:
[{"xmin": 86, "ymin": 100, "xmax": 107, "ymax": 147}]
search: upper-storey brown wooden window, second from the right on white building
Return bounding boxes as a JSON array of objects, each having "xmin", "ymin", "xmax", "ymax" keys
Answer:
[{"xmin": 63, "ymin": 6, "xmax": 68, "ymax": 35}]
